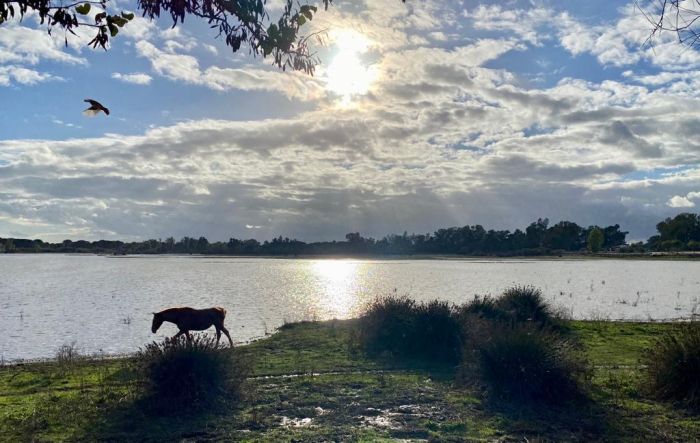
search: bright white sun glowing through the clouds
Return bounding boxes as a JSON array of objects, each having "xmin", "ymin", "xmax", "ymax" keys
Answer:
[{"xmin": 325, "ymin": 29, "xmax": 377, "ymax": 103}]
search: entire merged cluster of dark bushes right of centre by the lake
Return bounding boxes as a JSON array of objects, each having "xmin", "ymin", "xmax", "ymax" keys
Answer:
[{"xmin": 359, "ymin": 286, "xmax": 589, "ymax": 403}]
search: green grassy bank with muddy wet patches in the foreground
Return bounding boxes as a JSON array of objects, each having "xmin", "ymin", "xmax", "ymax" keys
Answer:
[{"xmin": 0, "ymin": 320, "xmax": 700, "ymax": 442}]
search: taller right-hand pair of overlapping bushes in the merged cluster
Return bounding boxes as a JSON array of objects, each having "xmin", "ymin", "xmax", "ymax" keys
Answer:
[{"xmin": 458, "ymin": 286, "xmax": 589, "ymax": 403}]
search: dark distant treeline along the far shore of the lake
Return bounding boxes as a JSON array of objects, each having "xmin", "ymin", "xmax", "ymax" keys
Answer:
[{"xmin": 0, "ymin": 213, "xmax": 700, "ymax": 256}]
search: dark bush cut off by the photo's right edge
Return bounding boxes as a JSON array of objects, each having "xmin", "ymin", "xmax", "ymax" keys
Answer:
[{"xmin": 643, "ymin": 322, "xmax": 700, "ymax": 408}]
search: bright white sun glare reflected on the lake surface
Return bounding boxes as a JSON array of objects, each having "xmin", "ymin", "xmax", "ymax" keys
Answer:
[{"xmin": 311, "ymin": 260, "xmax": 365, "ymax": 318}]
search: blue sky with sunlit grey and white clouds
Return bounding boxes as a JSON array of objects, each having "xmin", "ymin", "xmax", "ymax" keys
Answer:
[{"xmin": 0, "ymin": 0, "xmax": 700, "ymax": 241}]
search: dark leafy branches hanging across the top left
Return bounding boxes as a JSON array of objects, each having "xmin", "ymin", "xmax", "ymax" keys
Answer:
[{"xmin": 0, "ymin": 0, "xmax": 332, "ymax": 74}]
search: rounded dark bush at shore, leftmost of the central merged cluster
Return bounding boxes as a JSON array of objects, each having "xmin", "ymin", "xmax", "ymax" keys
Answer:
[{"xmin": 359, "ymin": 296, "xmax": 462, "ymax": 363}]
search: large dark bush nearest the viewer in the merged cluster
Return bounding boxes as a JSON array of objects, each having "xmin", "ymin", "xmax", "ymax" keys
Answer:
[{"xmin": 476, "ymin": 325, "xmax": 589, "ymax": 404}]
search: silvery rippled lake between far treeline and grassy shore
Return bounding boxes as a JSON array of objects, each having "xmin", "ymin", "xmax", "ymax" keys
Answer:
[{"xmin": 0, "ymin": 254, "xmax": 700, "ymax": 361}]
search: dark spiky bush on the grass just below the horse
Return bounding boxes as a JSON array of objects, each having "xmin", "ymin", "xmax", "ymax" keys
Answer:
[{"xmin": 136, "ymin": 334, "xmax": 248, "ymax": 413}]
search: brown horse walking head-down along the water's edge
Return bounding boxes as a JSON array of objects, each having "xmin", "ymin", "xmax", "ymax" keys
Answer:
[{"xmin": 151, "ymin": 308, "xmax": 233, "ymax": 347}]
